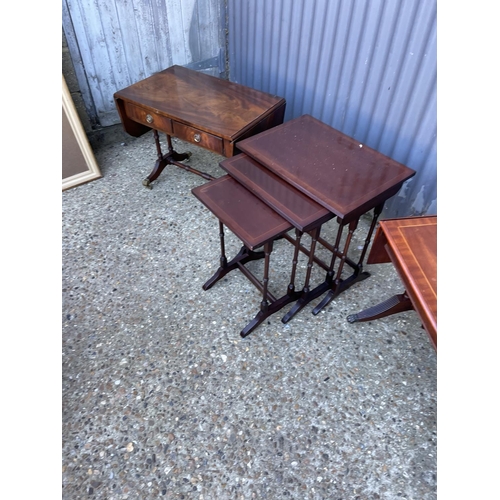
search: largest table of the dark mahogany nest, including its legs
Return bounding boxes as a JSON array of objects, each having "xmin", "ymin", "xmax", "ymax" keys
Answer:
[{"xmin": 237, "ymin": 115, "xmax": 415, "ymax": 323}]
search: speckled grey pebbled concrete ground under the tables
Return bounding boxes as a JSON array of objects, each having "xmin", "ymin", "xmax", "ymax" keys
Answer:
[{"xmin": 62, "ymin": 128, "xmax": 437, "ymax": 500}]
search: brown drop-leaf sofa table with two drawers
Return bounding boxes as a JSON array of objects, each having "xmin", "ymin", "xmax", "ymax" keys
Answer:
[{"xmin": 114, "ymin": 66, "xmax": 286, "ymax": 188}]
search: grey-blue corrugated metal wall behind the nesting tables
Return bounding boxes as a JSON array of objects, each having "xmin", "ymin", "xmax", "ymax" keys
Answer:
[{"xmin": 228, "ymin": 0, "xmax": 437, "ymax": 217}]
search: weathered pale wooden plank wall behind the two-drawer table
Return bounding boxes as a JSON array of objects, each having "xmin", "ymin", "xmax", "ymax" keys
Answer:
[{"xmin": 62, "ymin": 0, "xmax": 225, "ymax": 126}]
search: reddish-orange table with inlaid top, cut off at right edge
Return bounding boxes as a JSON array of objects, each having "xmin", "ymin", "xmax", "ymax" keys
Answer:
[{"xmin": 347, "ymin": 216, "xmax": 437, "ymax": 350}]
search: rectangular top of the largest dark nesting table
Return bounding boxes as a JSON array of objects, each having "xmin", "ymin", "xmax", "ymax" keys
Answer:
[{"xmin": 237, "ymin": 115, "xmax": 415, "ymax": 222}]
